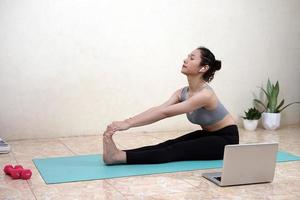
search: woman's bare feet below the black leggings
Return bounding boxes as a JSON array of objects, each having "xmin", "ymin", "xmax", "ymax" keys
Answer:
[{"xmin": 103, "ymin": 131, "xmax": 126, "ymax": 165}]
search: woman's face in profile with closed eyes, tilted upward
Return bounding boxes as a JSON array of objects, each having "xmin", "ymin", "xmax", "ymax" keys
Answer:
[{"xmin": 181, "ymin": 49, "xmax": 201, "ymax": 75}]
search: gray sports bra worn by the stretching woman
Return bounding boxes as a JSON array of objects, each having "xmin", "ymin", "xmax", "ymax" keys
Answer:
[{"xmin": 180, "ymin": 85, "xmax": 228, "ymax": 126}]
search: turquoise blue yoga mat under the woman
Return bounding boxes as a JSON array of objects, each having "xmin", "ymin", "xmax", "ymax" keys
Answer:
[{"xmin": 33, "ymin": 151, "xmax": 300, "ymax": 184}]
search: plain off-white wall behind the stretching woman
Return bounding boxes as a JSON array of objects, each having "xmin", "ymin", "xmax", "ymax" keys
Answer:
[{"xmin": 0, "ymin": 0, "xmax": 300, "ymax": 139}]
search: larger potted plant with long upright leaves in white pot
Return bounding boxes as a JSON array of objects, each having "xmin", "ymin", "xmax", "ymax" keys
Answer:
[{"xmin": 254, "ymin": 79, "xmax": 300, "ymax": 130}]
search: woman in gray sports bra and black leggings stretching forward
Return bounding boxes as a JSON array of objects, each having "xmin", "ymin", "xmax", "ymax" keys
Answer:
[{"xmin": 103, "ymin": 47, "xmax": 239, "ymax": 165}]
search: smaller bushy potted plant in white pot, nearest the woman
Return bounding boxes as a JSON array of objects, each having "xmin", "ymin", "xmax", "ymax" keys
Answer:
[{"xmin": 243, "ymin": 107, "xmax": 261, "ymax": 131}]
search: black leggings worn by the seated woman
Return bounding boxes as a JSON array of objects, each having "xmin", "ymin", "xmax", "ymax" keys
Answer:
[{"xmin": 124, "ymin": 125, "xmax": 239, "ymax": 164}]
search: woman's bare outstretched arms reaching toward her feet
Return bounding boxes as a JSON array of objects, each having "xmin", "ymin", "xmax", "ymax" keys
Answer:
[{"xmin": 109, "ymin": 90, "xmax": 211, "ymax": 131}]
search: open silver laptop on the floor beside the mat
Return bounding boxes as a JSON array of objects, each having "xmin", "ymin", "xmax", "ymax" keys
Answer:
[{"xmin": 202, "ymin": 143, "xmax": 278, "ymax": 186}]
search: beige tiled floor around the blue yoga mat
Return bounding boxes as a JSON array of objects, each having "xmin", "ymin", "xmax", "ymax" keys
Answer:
[{"xmin": 0, "ymin": 125, "xmax": 300, "ymax": 200}]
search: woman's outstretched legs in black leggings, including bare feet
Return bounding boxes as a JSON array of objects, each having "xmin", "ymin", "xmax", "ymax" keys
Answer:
[{"xmin": 103, "ymin": 126, "xmax": 239, "ymax": 164}]
